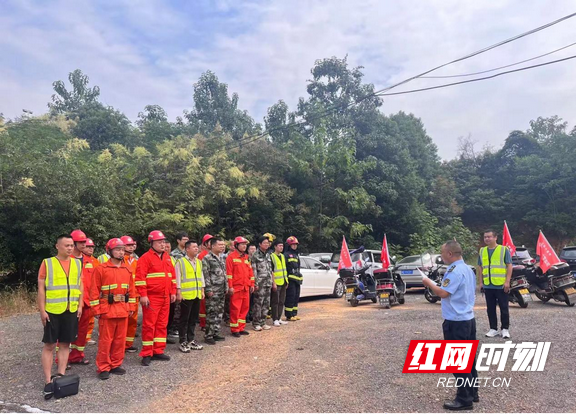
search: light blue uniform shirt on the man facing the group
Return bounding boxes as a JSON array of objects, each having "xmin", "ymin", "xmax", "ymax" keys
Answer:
[{"xmin": 441, "ymin": 260, "xmax": 476, "ymax": 321}]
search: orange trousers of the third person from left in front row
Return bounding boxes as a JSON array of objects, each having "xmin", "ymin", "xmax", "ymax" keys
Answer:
[{"xmin": 140, "ymin": 295, "xmax": 170, "ymax": 357}]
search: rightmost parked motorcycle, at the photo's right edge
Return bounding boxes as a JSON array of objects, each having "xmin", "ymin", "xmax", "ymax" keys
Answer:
[{"xmin": 526, "ymin": 263, "xmax": 576, "ymax": 306}]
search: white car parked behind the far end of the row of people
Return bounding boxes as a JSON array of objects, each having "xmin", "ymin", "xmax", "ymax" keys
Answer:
[{"xmin": 300, "ymin": 256, "xmax": 344, "ymax": 298}]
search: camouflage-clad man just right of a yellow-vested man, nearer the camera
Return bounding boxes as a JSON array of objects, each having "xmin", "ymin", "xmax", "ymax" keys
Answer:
[{"xmin": 202, "ymin": 237, "xmax": 228, "ymax": 345}]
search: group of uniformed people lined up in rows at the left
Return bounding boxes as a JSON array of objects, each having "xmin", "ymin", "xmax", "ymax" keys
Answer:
[{"xmin": 38, "ymin": 230, "xmax": 302, "ymax": 399}]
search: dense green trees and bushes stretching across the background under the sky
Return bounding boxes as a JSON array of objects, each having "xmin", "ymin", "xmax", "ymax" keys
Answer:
[{"xmin": 0, "ymin": 58, "xmax": 576, "ymax": 278}]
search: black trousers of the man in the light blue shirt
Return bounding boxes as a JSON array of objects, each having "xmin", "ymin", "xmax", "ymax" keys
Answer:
[{"xmin": 442, "ymin": 319, "xmax": 478, "ymax": 405}]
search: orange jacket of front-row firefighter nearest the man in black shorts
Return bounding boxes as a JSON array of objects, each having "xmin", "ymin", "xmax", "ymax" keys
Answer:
[{"xmin": 90, "ymin": 260, "xmax": 138, "ymax": 318}]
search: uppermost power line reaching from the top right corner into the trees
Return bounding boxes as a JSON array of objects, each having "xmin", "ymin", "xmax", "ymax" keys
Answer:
[{"xmin": 220, "ymin": 13, "xmax": 576, "ymax": 150}]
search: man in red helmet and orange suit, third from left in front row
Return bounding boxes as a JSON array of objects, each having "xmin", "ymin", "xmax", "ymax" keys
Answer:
[{"xmin": 136, "ymin": 230, "xmax": 176, "ymax": 366}]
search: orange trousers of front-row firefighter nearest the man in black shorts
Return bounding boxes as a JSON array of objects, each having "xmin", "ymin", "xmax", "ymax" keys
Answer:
[{"xmin": 96, "ymin": 318, "xmax": 128, "ymax": 372}]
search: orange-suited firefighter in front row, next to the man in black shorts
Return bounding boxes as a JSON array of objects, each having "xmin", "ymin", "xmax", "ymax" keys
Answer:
[{"xmin": 90, "ymin": 238, "xmax": 136, "ymax": 380}]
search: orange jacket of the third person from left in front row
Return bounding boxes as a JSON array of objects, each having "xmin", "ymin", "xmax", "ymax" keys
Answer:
[{"xmin": 136, "ymin": 249, "xmax": 176, "ymax": 297}]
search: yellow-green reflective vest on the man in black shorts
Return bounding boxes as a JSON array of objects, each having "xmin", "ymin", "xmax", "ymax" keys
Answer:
[{"xmin": 44, "ymin": 257, "xmax": 82, "ymax": 314}]
